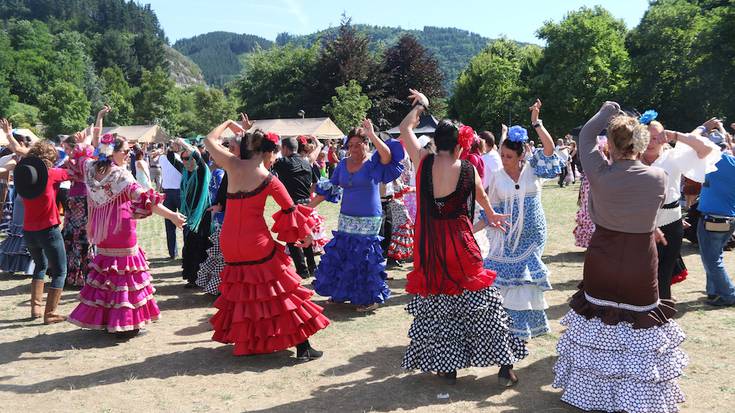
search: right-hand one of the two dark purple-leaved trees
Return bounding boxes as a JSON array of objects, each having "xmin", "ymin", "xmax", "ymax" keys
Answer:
[{"xmin": 381, "ymin": 34, "xmax": 445, "ymax": 125}]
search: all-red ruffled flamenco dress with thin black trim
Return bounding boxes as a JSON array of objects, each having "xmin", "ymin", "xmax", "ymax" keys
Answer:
[{"xmin": 210, "ymin": 175, "xmax": 329, "ymax": 356}]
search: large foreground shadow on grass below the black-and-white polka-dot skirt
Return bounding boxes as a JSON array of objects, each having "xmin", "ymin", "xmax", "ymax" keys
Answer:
[{"xmin": 246, "ymin": 346, "xmax": 572, "ymax": 413}]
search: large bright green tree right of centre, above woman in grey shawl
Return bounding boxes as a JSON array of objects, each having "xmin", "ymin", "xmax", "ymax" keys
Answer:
[{"xmin": 532, "ymin": 6, "xmax": 630, "ymax": 133}]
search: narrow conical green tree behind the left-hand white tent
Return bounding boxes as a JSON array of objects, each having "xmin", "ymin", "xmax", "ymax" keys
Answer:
[{"xmin": 135, "ymin": 67, "xmax": 179, "ymax": 134}]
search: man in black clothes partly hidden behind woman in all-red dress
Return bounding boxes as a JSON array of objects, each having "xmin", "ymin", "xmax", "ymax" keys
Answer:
[{"xmin": 272, "ymin": 137, "xmax": 321, "ymax": 279}]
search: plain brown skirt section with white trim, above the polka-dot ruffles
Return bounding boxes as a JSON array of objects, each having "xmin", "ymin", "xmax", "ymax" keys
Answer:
[{"xmin": 570, "ymin": 226, "xmax": 676, "ymax": 328}]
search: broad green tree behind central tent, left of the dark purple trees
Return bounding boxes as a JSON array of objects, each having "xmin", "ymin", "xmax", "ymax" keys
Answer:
[{"xmin": 233, "ymin": 45, "xmax": 318, "ymax": 119}]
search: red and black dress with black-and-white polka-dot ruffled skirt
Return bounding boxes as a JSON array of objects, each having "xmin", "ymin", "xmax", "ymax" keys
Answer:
[{"xmin": 402, "ymin": 155, "xmax": 528, "ymax": 373}]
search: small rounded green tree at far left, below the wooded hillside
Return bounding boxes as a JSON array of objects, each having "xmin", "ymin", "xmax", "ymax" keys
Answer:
[{"xmin": 38, "ymin": 81, "xmax": 91, "ymax": 136}]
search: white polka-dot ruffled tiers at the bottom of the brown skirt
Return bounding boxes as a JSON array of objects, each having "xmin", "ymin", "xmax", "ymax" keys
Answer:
[{"xmin": 553, "ymin": 310, "xmax": 688, "ymax": 413}]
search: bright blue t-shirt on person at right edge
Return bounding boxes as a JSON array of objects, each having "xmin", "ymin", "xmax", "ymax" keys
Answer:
[{"xmin": 698, "ymin": 153, "xmax": 735, "ymax": 217}]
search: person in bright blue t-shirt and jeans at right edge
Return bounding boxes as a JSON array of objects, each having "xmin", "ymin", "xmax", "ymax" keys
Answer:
[{"xmin": 697, "ymin": 119, "xmax": 735, "ymax": 307}]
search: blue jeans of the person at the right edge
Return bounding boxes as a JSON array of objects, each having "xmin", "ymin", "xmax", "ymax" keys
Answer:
[{"xmin": 697, "ymin": 217, "xmax": 735, "ymax": 304}]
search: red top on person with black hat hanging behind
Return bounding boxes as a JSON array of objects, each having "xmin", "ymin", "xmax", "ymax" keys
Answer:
[{"xmin": 21, "ymin": 168, "xmax": 69, "ymax": 231}]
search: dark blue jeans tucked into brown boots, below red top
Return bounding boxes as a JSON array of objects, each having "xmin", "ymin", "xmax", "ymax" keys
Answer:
[{"xmin": 23, "ymin": 226, "xmax": 66, "ymax": 288}]
